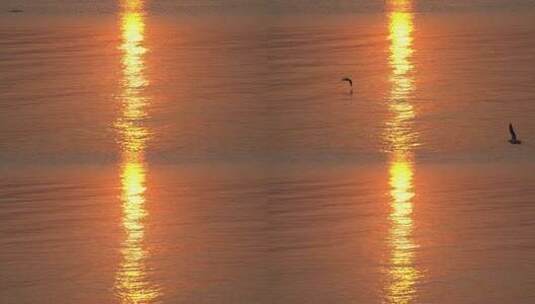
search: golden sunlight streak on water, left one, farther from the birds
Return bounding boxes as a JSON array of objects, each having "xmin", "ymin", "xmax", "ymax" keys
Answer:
[{"xmin": 115, "ymin": 0, "xmax": 159, "ymax": 303}]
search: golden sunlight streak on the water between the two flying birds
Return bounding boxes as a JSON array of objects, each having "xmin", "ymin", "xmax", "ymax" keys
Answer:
[{"xmin": 385, "ymin": 0, "xmax": 421, "ymax": 304}]
